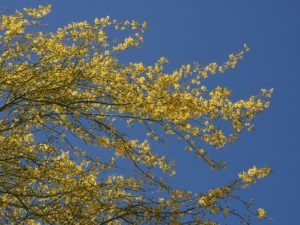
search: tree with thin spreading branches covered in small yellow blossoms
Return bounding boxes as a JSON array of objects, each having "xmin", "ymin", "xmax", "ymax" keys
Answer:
[{"xmin": 0, "ymin": 5, "xmax": 273, "ymax": 224}]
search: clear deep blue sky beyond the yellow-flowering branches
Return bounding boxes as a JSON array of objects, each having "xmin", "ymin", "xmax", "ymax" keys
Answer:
[{"xmin": 0, "ymin": 0, "xmax": 300, "ymax": 225}]
